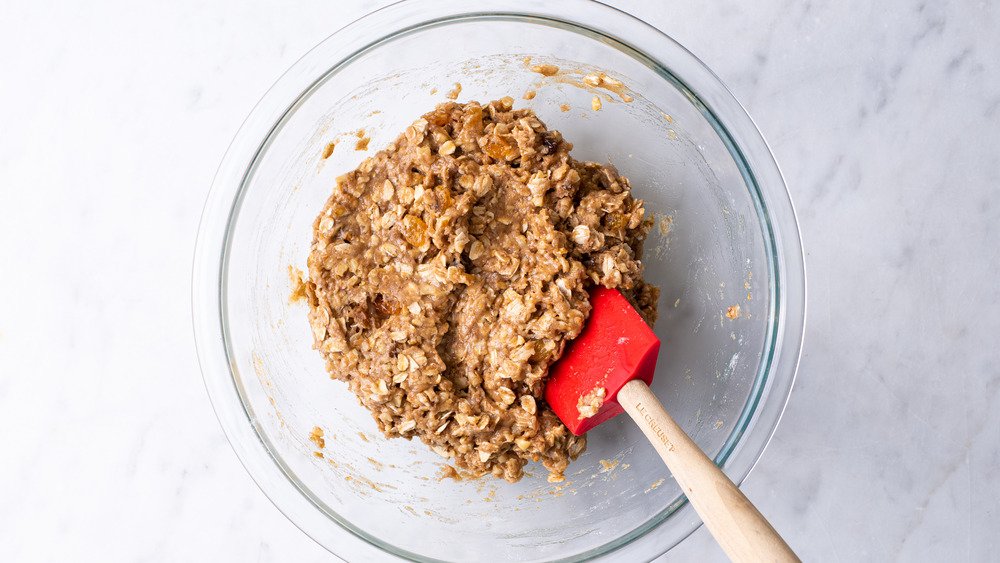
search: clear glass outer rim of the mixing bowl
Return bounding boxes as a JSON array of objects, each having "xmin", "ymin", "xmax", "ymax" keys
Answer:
[{"xmin": 192, "ymin": 0, "xmax": 806, "ymax": 561}]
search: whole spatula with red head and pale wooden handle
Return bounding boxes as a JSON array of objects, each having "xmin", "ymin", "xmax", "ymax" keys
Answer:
[{"xmin": 545, "ymin": 287, "xmax": 799, "ymax": 561}]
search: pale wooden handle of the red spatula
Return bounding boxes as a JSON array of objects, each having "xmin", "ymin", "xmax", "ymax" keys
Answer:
[{"xmin": 618, "ymin": 379, "xmax": 799, "ymax": 562}]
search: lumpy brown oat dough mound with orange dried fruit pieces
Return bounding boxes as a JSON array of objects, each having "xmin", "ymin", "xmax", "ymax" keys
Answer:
[{"xmin": 306, "ymin": 98, "xmax": 659, "ymax": 481}]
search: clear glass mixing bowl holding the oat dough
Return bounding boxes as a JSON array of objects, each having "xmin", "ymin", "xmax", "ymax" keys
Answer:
[{"xmin": 193, "ymin": 0, "xmax": 805, "ymax": 561}]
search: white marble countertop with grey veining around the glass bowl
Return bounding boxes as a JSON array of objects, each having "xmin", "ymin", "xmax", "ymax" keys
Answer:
[{"xmin": 0, "ymin": 0, "xmax": 1000, "ymax": 562}]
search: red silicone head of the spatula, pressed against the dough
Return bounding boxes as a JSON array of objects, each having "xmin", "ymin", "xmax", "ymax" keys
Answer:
[{"xmin": 545, "ymin": 287, "xmax": 660, "ymax": 436}]
